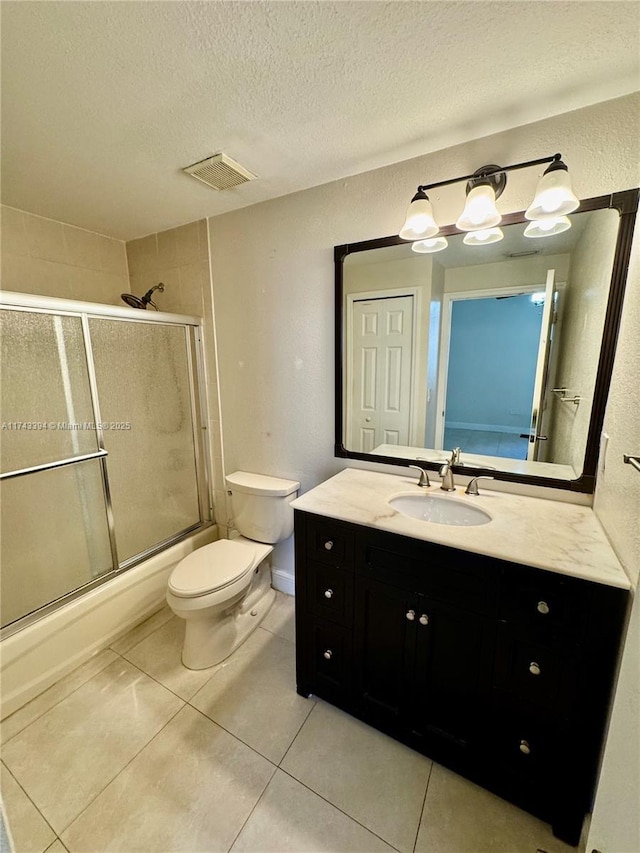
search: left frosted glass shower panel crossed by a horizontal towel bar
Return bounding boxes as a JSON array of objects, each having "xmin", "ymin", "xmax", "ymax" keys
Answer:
[{"xmin": 0, "ymin": 310, "xmax": 114, "ymax": 627}]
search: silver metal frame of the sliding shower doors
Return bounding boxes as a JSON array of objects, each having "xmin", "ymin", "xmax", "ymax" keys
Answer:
[{"xmin": 0, "ymin": 291, "xmax": 214, "ymax": 640}]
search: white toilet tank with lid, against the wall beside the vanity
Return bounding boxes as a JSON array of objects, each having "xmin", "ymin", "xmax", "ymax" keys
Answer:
[{"xmin": 226, "ymin": 471, "xmax": 300, "ymax": 544}]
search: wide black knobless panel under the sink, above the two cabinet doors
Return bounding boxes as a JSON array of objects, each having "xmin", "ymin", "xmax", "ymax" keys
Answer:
[{"xmin": 356, "ymin": 534, "xmax": 499, "ymax": 615}]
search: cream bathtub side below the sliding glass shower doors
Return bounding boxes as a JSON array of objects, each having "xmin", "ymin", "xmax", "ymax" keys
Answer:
[{"xmin": 0, "ymin": 525, "xmax": 218, "ymax": 719}]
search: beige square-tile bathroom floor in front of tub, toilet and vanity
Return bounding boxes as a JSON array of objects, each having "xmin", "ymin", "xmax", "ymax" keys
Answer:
[{"xmin": 1, "ymin": 593, "xmax": 575, "ymax": 853}]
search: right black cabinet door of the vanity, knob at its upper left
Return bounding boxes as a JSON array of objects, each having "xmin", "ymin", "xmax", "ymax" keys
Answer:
[{"xmin": 410, "ymin": 596, "xmax": 495, "ymax": 746}]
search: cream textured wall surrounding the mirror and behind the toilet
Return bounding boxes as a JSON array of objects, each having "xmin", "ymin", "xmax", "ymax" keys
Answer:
[{"xmin": 209, "ymin": 93, "xmax": 640, "ymax": 853}]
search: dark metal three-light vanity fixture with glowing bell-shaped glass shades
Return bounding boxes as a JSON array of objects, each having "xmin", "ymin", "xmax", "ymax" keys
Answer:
[{"xmin": 400, "ymin": 154, "xmax": 580, "ymax": 246}]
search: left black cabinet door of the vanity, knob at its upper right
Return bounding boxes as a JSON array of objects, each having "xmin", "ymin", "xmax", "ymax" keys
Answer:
[{"xmin": 354, "ymin": 577, "xmax": 418, "ymax": 725}]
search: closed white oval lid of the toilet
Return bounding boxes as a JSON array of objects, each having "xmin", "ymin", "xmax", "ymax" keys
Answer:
[{"xmin": 169, "ymin": 539, "xmax": 255, "ymax": 598}]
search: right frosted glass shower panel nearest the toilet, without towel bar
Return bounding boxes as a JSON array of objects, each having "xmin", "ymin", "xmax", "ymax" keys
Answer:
[{"xmin": 89, "ymin": 317, "xmax": 206, "ymax": 565}]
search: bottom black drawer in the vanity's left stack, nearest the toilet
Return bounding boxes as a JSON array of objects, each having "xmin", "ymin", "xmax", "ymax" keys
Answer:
[{"xmin": 307, "ymin": 619, "xmax": 353, "ymax": 699}]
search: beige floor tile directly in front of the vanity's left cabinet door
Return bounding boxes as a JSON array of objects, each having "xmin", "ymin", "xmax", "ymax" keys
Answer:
[{"xmin": 282, "ymin": 702, "xmax": 432, "ymax": 853}]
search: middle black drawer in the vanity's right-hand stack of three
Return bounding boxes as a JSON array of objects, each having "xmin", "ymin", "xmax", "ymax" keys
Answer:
[{"xmin": 493, "ymin": 623, "xmax": 580, "ymax": 717}]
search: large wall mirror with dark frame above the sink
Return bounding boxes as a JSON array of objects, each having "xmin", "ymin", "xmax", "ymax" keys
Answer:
[{"xmin": 335, "ymin": 190, "xmax": 639, "ymax": 492}]
